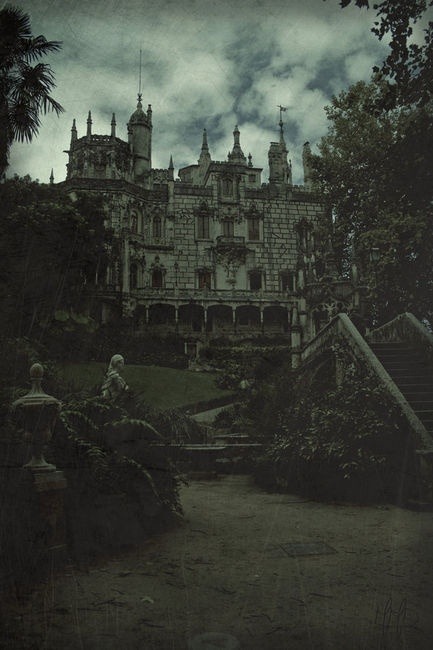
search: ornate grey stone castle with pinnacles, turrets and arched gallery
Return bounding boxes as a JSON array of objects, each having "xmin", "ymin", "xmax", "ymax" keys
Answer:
[{"xmin": 60, "ymin": 95, "xmax": 360, "ymax": 360}]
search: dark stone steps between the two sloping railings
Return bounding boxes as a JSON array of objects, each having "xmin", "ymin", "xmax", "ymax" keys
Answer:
[{"xmin": 370, "ymin": 341, "xmax": 433, "ymax": 436}]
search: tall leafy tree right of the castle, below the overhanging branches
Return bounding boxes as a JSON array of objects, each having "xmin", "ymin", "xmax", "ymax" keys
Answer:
[{"xmin": 313, "ymin": 79, "xmax": 433, "ymax": 322}]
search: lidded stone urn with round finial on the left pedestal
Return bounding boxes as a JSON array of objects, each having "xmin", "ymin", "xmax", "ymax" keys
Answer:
[{"xmin": 12, "ymin": 363, "xmax": 61, "ymax": 472}]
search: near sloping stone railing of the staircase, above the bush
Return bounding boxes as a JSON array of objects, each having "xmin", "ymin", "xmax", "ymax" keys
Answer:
[{"xmin": 301, "ymin": 314, "xmax": 433, "ymax": 452}]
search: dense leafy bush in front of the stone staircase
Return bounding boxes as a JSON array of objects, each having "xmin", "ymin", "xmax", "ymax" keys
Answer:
[{"xmin": 250, "ymin": 345, "xmax": 413, "ymax": 500}]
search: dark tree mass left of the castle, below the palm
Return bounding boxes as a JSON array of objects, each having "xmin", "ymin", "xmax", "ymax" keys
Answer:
[{"xmin": 0, "ymin": 177, "xmax": 104, "ymax": 343}]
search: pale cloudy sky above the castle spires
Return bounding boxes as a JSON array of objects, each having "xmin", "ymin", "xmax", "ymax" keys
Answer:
[{"xmin": 8, "ymin": 0, "xmax": 387, "ymax": 183}]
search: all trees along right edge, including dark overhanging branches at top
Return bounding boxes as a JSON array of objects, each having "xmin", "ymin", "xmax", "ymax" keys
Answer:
[{"xmin": 313, "ymin": 0, "xmax": 433, "ymax": 324}]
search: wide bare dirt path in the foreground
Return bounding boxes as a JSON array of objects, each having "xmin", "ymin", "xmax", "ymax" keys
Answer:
[{"xmin": 0, "ymin": 476, "xmax": 433, "ymax": 650}]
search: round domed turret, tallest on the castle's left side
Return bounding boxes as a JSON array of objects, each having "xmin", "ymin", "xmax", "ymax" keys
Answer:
[{"xmin": 128, "ymin": 94, "xmax": 152, "ymax": 185}]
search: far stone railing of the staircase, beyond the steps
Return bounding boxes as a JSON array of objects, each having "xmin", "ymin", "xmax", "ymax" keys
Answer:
[{"xmin": 366, "ymin": 312, "xmax": 433, "ymax": 362}]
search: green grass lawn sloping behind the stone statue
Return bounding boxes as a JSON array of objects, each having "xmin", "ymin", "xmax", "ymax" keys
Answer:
[{"xmin": 62, "ymin": 362, "xmax": 231, "ymax": 409}]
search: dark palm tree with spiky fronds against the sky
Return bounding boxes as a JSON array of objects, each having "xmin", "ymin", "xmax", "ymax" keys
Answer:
[{"xmin": 0, "ymin": 5, "xmax": 63, "ymax": 178}]
